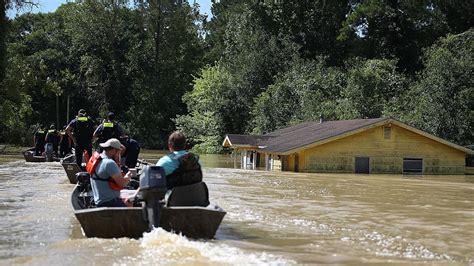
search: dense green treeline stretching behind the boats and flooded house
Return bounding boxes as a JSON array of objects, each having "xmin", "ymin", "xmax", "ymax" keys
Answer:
[{"xmin": 0, "ymin": 0, "xmax": 474, "ymax": 152}]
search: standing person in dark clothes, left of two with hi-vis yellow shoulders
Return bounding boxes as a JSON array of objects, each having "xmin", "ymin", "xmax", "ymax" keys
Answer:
[{"xmin": 66, "ymin": 109, "xmax": 95, "ymax": 167}]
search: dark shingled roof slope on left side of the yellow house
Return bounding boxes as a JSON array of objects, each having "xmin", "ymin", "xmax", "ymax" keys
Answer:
[{"xmin": 260, "ymin": 118, "xmax": 388, "ymax": 153}]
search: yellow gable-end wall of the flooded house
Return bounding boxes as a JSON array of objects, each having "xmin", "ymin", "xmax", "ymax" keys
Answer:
[{"xmin": 299, "ymin": 125, "xmax": 465, "ymax": 174}]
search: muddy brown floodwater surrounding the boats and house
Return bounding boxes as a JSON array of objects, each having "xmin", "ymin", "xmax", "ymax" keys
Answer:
[{"xmin": 0, "ymin": 151, "xmax": 474, "ymax": 265}]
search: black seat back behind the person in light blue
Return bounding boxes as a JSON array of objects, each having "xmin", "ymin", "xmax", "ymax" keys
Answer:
[{"xmin": 166, "ymin": 182, "xmax": 209, "ymax": 207}]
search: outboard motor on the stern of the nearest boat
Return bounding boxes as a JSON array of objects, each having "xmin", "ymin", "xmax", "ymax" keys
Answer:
[{"xmin": 139, "ymin": 165, "xmax": 168, "ymax": 230}]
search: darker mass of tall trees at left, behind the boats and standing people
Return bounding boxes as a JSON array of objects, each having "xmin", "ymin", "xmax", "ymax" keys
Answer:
[{"xmin": 3, "ymin": 0, "xmax": 204, "ymax": 147}]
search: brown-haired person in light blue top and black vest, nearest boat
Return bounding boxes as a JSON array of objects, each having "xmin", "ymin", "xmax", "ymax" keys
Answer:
[{"xmin": 156, "ymin": 131, "xmax": 202, "ymax": 189}]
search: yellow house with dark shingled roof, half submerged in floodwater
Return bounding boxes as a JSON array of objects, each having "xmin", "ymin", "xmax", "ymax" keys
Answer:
[{"xmin": 223, "ymin": 118, "xmax": 474, "ymax": 174}]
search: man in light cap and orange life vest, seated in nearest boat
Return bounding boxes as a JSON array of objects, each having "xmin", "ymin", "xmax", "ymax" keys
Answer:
[{"xmin": 89, "ymin": 138, "xmax": 132, "ymax": 207}]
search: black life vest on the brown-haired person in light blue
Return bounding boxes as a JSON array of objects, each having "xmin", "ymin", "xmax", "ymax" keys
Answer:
[{"xmin": 166, "ymin": 153, "xmax": 202, "ymax": 189}]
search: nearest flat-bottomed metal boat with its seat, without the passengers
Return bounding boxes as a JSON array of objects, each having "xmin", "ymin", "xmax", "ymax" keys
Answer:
[{"xmin": 71, "ymin": 166, "xmax": 226, "ymax": 239}]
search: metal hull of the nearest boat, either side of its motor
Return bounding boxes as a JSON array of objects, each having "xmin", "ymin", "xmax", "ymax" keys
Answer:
[{"xmin": 71, "ymin": 186, "xmax": 226, "ymax": 239}]
